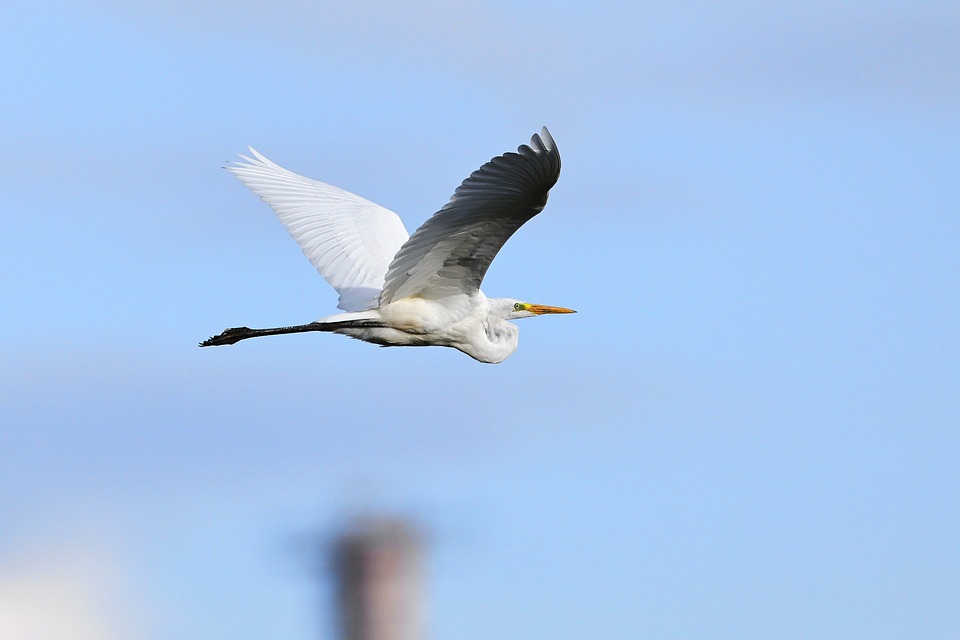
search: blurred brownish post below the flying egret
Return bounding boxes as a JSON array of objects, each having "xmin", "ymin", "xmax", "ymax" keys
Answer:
[{"xmin": 333, "ymin": 518, "xmax": 424, "ymax": 640}]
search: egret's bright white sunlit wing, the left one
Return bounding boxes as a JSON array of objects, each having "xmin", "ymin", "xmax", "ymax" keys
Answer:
[{"xmin": 227, "ymin": 148, "xmax": 408, "ymax": 311}]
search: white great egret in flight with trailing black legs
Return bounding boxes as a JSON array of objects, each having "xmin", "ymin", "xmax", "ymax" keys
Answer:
[{"xmin": 200, "ymin": 127, "xmax": 575, "ymax": 363}]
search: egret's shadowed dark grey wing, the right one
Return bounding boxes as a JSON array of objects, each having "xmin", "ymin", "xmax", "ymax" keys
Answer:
[{"xmin": 380, "ymin": 127, "xmax": 560, "ymax": 305}]
